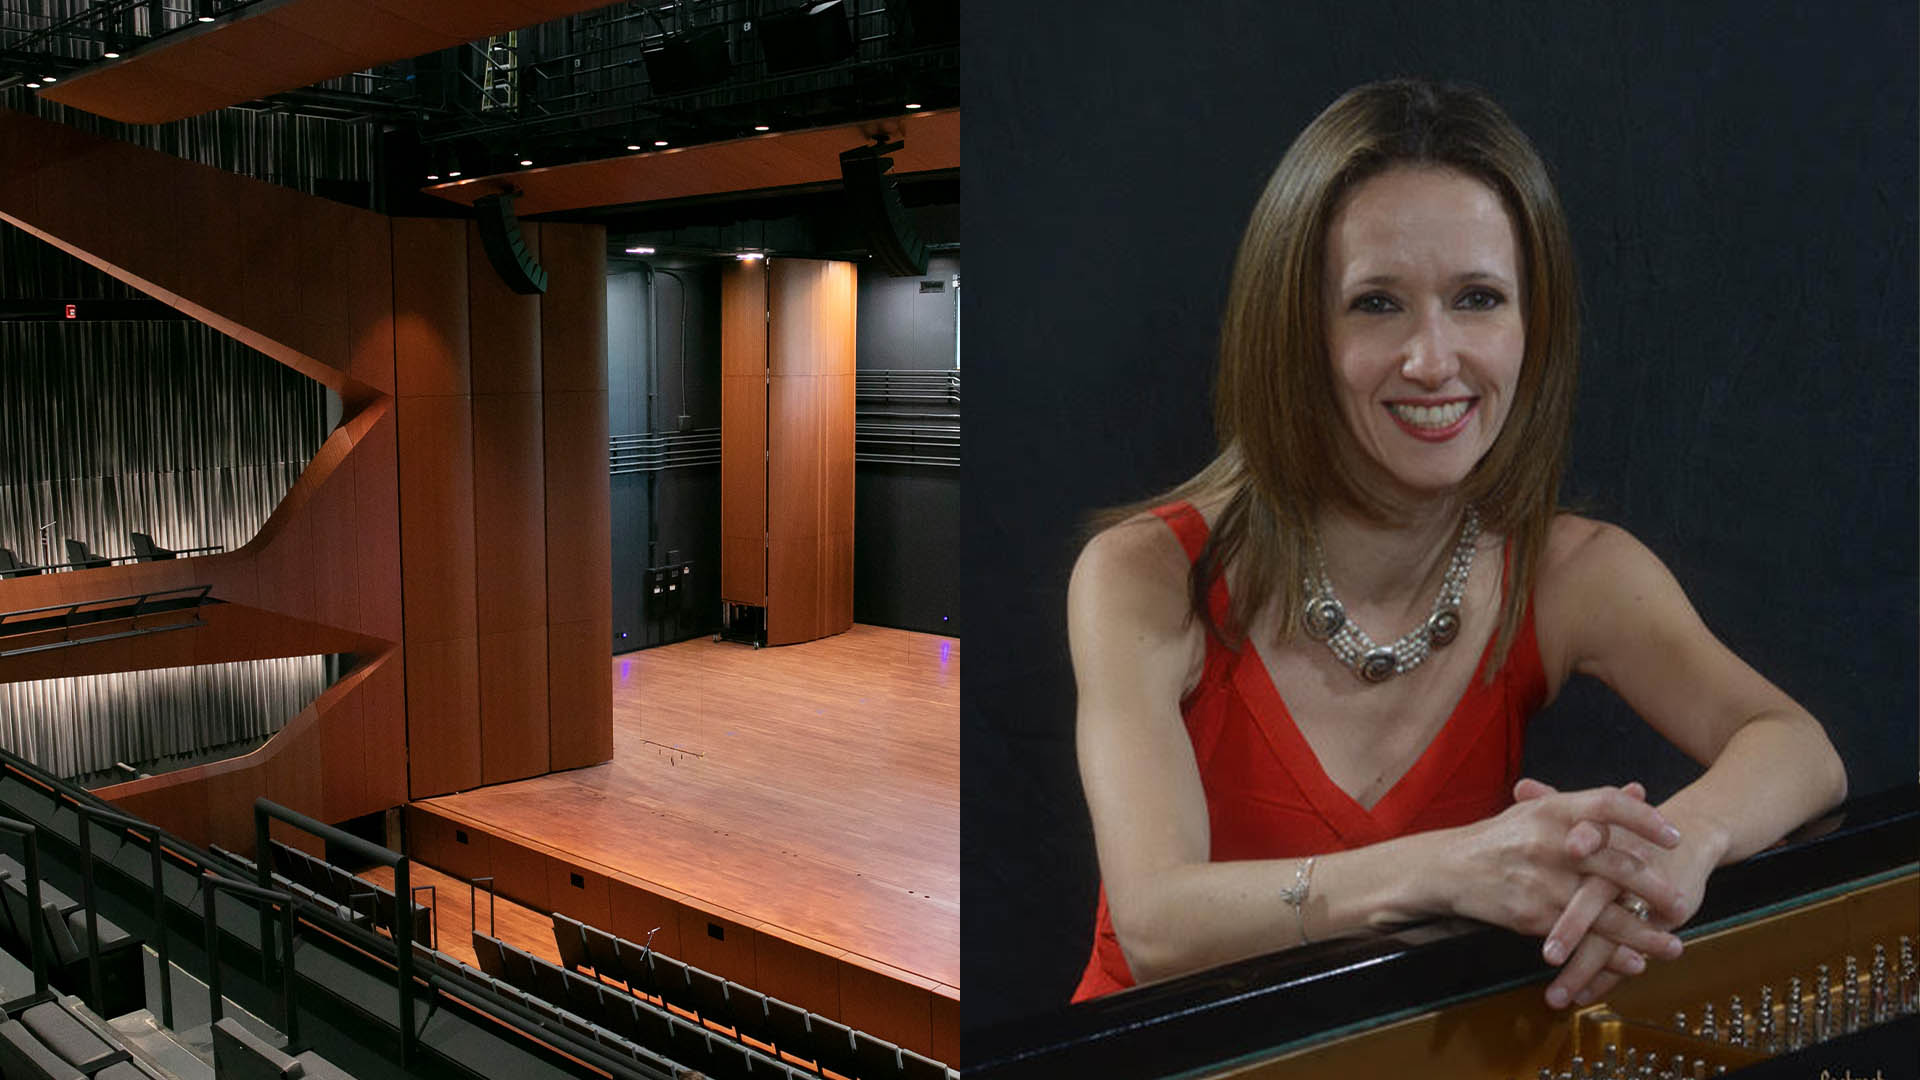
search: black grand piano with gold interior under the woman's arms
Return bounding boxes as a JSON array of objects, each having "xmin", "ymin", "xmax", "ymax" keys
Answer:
[{"xmin": 964, "ymin": 786, "xmax": 1920, "ymax": 1080}]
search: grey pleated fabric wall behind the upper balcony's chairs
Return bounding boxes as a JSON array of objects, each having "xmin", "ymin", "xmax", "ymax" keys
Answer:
[{"xmin": 0, "ymin": 321, "xmax": 326, "ymax": 563}]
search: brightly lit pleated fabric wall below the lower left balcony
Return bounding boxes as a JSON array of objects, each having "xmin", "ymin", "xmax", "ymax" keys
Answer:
[{"xmin": 0, "ymin": 645, "xmax": 326, "ymax": 778}]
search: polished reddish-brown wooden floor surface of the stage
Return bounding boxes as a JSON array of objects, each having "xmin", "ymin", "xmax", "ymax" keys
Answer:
[{"xmin": 422, "ymin": 625, "xmax": 960, "ymax": 995}]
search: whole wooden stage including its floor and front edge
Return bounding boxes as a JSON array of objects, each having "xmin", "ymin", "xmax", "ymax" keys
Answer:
[{"xmin": 409, "ymin": 625, "xmax": 960, "ymax": 1061}]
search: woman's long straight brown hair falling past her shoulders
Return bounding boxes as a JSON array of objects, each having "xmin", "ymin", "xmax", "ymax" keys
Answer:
[{"xmin": 1106, "ymin": 79, "xmax": 1580, "ymax": 675}]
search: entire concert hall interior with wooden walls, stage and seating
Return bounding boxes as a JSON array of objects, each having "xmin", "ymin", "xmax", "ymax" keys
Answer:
[{"xmin": 0, "ymin": 0, "xmax": 962, "ymax": 1080}]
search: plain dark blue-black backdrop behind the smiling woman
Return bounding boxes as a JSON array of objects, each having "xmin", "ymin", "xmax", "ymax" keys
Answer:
[{"xmin": 962, "ymin": 0, "xmax": 1920, "ymax": 1030}]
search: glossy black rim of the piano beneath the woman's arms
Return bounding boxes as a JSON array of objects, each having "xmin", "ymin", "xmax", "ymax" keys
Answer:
[{"xmin": 962, "ymin": 786, "xmax": 1920, "ymax": 1080}]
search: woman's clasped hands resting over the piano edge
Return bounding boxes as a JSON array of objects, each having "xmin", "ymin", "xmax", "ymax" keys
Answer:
[{"xmin": 1453, "ymin": 780, "xmax": 1711, "ymax": 1009}]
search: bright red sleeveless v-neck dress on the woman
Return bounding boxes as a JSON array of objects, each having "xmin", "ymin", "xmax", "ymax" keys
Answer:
[{"xmin": 1073, "ymin": 502, "xmax": 1548, "ymax": 1001}]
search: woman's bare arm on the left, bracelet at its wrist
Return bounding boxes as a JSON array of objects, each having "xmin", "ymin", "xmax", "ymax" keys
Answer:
[{"xmin": 1068, "ymin": 519, "xmax": 1678, "ymax": 982}]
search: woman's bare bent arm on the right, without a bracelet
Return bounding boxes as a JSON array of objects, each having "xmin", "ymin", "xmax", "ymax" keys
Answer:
[{"xmin": 1536, "ymin": 515, "xmax": 1847, "ymax": 1001}]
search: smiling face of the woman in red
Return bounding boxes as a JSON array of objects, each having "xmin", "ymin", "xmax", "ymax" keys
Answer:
[{"xmin": 1325, "ymin": 167, "xmax": 1526, "ymax": 500}]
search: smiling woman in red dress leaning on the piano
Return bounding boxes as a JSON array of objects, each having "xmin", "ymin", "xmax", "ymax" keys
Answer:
[{"xmin": 1068, "ymin": 81, "xmax": 1845, "ymax": 1009}]
